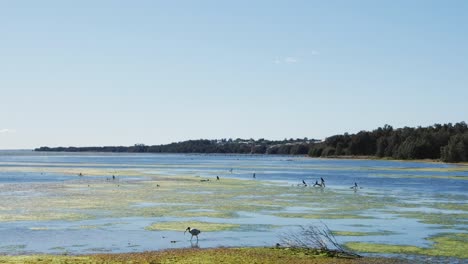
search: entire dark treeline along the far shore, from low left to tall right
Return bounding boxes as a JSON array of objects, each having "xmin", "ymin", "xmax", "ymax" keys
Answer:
[{"xmin": 35, "ymin": 122, "xmax": 468, "ymax": 162}]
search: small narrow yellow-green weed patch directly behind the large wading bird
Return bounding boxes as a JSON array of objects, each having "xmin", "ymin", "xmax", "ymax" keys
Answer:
[{"xmin": 146, "ymin": 221, "xmax": 240, "ymax": 232}]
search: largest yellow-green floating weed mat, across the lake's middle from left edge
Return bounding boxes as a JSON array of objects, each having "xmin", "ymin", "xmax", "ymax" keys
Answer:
[{"xmin": 0, "ymin": 171, "xmax": 414, "ymax": 224}]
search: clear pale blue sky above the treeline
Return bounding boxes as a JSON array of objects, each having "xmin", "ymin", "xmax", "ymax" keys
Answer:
[{"xmin": 0, "ymin": 0, "xmax": 468, "ymax": 149}]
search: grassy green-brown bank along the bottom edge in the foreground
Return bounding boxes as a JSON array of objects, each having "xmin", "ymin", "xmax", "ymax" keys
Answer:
[{"xmin": 0, "ymin": 248, "xmax": 406, "ymax": 264}]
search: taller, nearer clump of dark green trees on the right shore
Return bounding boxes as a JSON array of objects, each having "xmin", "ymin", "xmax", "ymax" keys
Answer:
[{"xmin": 309, "ymin": 122, "xmax": 468, "ymax": 162}]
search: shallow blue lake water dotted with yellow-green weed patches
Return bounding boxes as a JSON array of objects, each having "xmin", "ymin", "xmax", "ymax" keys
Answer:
[{"xmin": 0, "ymin": 151, "xmax": 468, "ymax": 260}]
